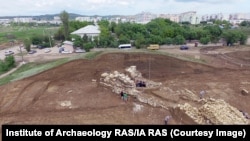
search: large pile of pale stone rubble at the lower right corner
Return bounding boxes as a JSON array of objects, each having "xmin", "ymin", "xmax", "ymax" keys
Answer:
[{"xmin": 172, "ymin": 98, "xmax": 249, "ymax": 125}]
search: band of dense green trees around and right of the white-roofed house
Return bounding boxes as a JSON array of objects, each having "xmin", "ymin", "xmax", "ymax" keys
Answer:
[{"xmin": 54, "ymin": 11, "xmax": 248, "ymax": 51}]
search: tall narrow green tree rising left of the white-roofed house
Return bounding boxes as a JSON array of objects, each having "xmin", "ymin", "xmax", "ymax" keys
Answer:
[{"xmin": 60, "ymin": 10, "xmax": 69, "ymax": 40}]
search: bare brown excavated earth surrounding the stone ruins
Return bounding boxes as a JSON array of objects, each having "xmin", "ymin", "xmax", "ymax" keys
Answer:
[{"xmin": 0, "ymin": 46, "xmax": 250, "ymax": 124}]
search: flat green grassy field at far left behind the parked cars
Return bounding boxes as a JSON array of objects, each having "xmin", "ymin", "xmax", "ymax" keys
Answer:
[{"xmin": 0, "ymin": 26, "xmax": 58, "ymax": 44}]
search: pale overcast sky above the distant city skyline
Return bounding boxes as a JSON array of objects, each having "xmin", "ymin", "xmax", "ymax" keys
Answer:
[{"xmin": 0, "ymin": 0, "xmax": 250, "ymax": 16}]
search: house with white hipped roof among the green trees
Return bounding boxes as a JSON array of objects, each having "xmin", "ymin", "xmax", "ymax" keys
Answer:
[{"xmin": 71, "ymin": 25, "xmax": 101, "ymax": 40}]
